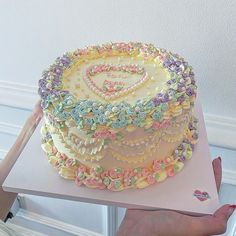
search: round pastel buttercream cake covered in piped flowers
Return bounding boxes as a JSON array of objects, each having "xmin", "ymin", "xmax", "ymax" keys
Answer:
[{"xmin": 39, "ymin": 42, "xmax": 198, "ymax": 191}]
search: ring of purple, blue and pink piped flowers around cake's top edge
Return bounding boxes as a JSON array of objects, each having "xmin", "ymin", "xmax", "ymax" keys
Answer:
[{"xmin": 39, "ymin": 42, "xmax": 197, "ymax": 141}]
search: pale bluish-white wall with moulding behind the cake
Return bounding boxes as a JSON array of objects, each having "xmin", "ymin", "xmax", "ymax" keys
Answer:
[{"xmin": 0, "ymin": 0, "xmax": 236, "ymax": 235}]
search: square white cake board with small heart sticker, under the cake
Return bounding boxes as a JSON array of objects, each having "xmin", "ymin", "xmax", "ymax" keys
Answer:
[{"xmin": 3, "ymin": 103, "xmax": 219, "ymax": 214}]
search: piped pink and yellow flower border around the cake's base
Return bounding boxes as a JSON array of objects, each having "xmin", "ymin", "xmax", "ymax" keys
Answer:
[{"xmin": 42, "ymin": 118, "xmax": 198, "ymax": 191}]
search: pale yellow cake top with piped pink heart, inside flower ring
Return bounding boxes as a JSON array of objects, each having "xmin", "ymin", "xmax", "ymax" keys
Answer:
[{"xmin": 62, "ymin": 44, "xmax": 170, "ymax": 104}]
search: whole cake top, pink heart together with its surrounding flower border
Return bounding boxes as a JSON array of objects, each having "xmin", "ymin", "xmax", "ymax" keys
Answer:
[{"xmin": 39, "ymin": 42, "xmax": 196, "ymax": 130}]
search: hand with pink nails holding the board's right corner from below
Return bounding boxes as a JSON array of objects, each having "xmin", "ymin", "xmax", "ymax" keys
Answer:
[{"xmin": 117, "ymin": 158, "xmax": 236, "ymax": 236}]
